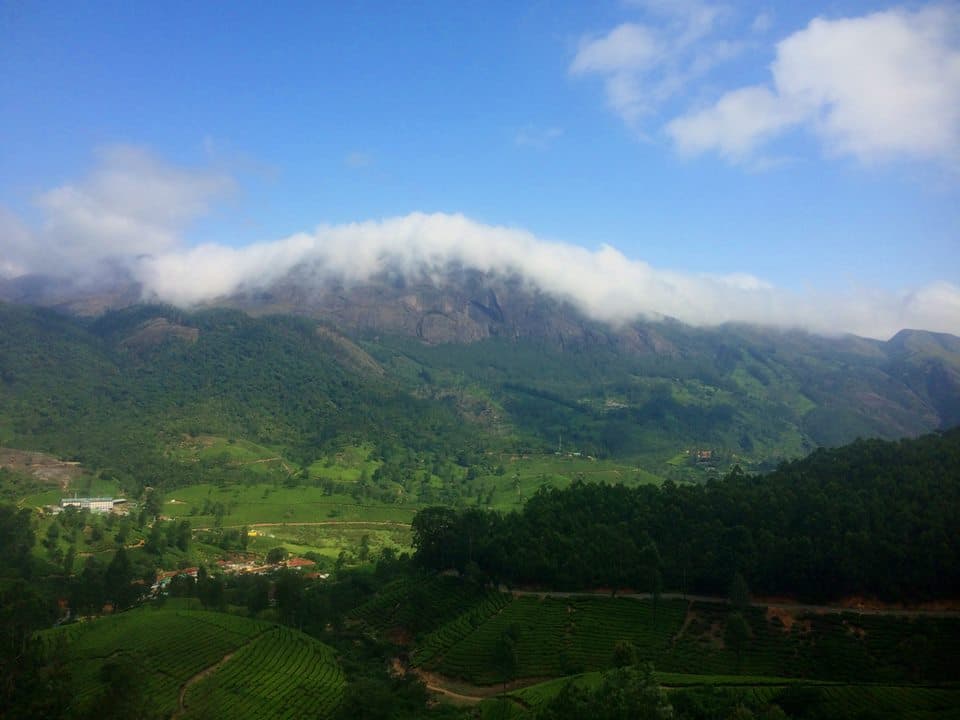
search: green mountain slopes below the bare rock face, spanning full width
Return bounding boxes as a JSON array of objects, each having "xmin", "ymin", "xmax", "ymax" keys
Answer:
[{"xmin": 0, "ymin": 304, "xmax": 960, "ymax": 504}]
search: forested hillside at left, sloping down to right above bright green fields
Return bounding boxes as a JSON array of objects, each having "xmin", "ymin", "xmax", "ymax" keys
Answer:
[{"xmin": 0, "ymin": 305, "xmax": 472, "ymax": 492}]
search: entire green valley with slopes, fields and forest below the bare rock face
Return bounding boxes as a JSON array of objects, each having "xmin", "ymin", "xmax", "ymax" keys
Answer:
[{"xmin": 0, "ymin": 302, "xmax": 960, "ymax": 720}]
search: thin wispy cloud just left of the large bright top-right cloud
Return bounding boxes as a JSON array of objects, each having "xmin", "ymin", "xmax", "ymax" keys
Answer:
[{"xmin": 570, "ymin": 0, "xmax": 742, "ymax": 130}]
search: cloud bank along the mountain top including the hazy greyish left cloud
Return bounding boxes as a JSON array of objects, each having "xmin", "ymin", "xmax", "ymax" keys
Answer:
[{"xmin": 0, "ymin": 148, "xmax": 960, "ymax": 338}]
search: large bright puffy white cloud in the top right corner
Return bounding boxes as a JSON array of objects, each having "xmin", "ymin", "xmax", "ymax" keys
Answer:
[{"xmin": 667, "ymin": 6, "xmax": 960, "ymax": 163}]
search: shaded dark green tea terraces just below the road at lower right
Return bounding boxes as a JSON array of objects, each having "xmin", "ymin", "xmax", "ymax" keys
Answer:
[{"xmin": 412, "ymin": 596, "xmax": 960, "ymax": 685}]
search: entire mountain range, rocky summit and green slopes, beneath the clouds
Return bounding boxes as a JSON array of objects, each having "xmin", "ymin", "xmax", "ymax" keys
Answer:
[{"xmin": 0, "ymin": 267, "xmax": 960, "ymax": 484}]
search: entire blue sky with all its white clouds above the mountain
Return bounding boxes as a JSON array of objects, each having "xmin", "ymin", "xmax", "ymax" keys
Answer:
[{"xmin": 0, "ymin": 0, "xmax": 960, "ymax": 338}]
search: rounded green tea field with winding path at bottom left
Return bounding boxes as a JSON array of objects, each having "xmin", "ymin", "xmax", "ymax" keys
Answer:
[{"xmin": 41, "ymin": 607, "xmax": 344, "ymax": 718}]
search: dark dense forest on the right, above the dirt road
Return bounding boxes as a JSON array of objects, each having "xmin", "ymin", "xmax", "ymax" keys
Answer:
[{"xmin": 413, "ymin": 428, "xmax": 960, "ymax": 600}]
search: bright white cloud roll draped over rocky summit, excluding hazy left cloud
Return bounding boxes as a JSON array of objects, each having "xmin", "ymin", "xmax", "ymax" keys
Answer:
[{"xmin": 127, "ymin": 213, "xmax": 960, "ymax": 338}]
